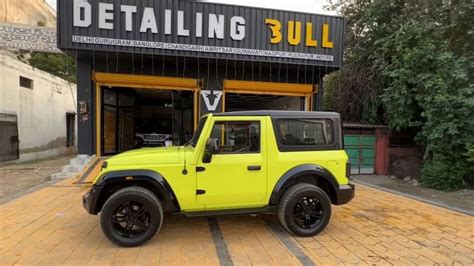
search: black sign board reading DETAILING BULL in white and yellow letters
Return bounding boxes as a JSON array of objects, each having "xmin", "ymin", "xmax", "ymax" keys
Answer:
[{"xmin": 58, "ymin": 0, "xmax": 344, "ymax": 67}]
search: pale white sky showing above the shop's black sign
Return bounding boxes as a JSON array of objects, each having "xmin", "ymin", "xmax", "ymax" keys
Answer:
[{"xmin": 46, "ymin": 0, "xmax": 335, "ymax": 15}]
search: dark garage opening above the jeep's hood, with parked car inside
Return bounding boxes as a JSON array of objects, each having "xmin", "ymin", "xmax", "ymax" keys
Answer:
[{"xmin": 100, "ymin": 87, "xmax": 195, "ymax": 155}]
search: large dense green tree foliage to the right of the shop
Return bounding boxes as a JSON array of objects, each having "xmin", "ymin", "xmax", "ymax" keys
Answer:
[{"xmin": 326, "ymin": 0, "xmax": 474, "ymax": 190}]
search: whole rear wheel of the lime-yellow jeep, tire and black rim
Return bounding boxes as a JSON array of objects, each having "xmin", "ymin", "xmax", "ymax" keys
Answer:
[{"xmin": 278, "ymin": 183, "xmax": 331, "ymax": 236}]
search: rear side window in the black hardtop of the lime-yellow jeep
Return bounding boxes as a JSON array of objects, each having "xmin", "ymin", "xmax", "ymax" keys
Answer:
[{"xmin": 277, "ymin": 119, "xmax": 334, "ymax": 146}]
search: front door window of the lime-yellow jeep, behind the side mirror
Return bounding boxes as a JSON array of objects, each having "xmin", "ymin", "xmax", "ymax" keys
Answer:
[{"xmin": 211, "ymin": 121, "xmax": 260, "ymax": 154}]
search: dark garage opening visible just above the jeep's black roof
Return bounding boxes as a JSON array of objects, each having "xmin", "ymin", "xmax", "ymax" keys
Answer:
[{"xmin": 225, "ymin": 93, "xmax": 306, "ymax": 112}]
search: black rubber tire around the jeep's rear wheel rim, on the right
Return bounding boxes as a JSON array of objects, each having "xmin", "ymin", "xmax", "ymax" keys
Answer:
[{"xmin": 278, "ymin": 183, "xmax": 331, "ymax": 237}]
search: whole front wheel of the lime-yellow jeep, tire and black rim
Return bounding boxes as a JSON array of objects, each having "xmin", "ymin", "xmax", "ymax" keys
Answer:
[{"xmin": 100, "ymin": 187, "xmax": 163, "ymax": 247}]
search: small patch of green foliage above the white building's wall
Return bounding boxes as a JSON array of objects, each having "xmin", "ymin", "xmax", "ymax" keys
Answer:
[{"xmin": 28, "ymin": 52, "xmax": 76, "ymax": 83}]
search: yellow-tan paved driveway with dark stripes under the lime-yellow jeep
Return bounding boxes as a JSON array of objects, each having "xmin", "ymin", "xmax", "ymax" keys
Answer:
[{"xmin": 0, "ymin": 180, "xmax": 474, "ymax": 265}]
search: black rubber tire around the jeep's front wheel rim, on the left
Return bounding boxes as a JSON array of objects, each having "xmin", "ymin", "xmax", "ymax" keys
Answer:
[{"xmin": 100, "ymin": 186, "xmax": 163, "ymax": 247}]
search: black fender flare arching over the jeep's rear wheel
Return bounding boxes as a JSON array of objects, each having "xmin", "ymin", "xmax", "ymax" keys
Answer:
[{"xmin": 269, "ymin": 164, "xmax": 339, "ymax": 205}]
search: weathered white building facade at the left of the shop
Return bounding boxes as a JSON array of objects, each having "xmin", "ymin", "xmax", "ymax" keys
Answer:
[{"xmin": 0, "ymin": 51, "xmax": 77, "ymax": 163}]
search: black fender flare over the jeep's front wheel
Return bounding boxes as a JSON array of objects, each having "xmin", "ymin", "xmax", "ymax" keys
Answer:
[{"xmin": 97, "ymin": 170, "xmax": 180, "ymax": 212}]
